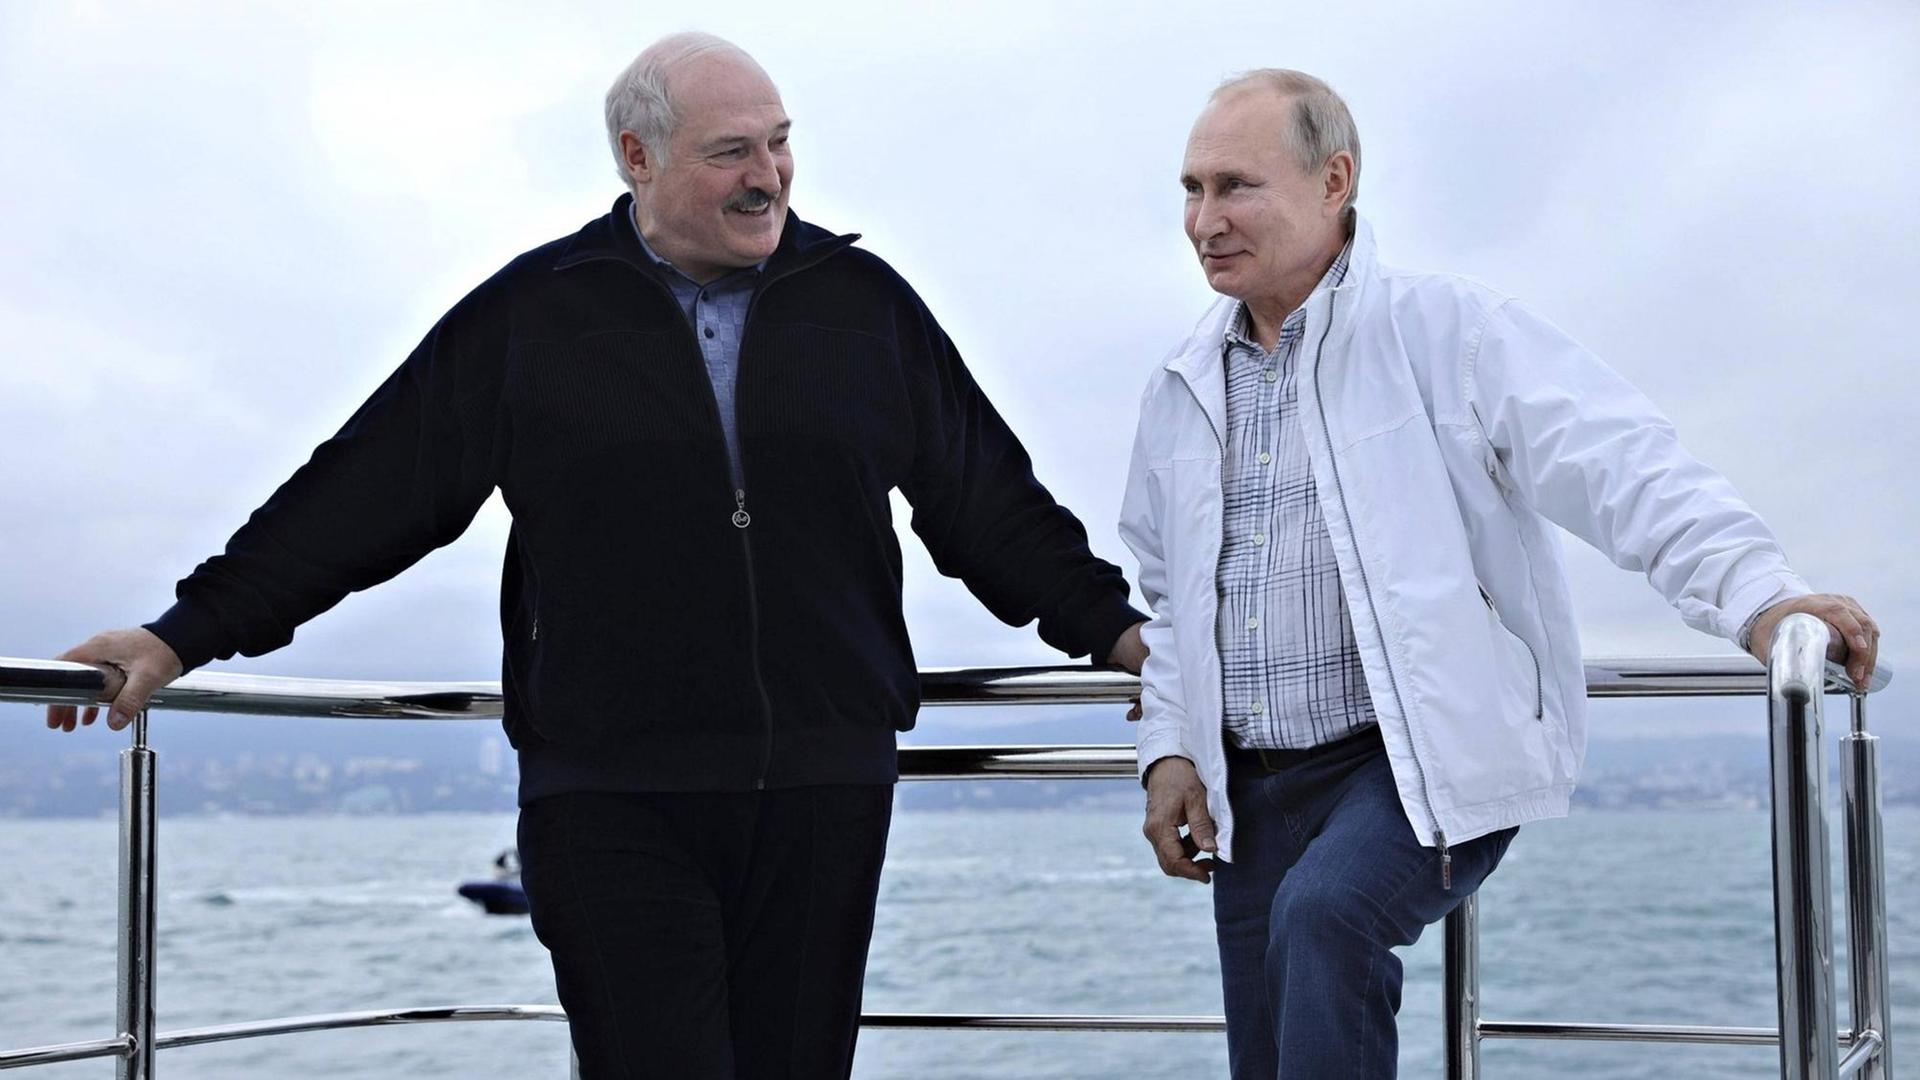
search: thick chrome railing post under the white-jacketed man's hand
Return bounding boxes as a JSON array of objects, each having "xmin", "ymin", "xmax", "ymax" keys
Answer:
[{"xmin": 1766, "ymin": 615, "xmax": 1839, "ymax": 1080}]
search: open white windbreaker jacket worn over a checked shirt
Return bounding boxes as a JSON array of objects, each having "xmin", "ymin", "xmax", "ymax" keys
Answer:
[{"xmin": 1119, "ymin": 221, "xmax": 1807, "ymax": 861}]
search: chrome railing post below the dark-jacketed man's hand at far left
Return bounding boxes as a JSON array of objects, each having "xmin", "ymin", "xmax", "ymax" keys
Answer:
[{"xmin": 117, "ymin": 709, "xmax": 156, "ymax": 1080}]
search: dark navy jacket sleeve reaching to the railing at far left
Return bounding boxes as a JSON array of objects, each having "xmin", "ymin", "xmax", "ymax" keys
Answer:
[{"xmin": 146, "ymin": 290, "xmax": 499, "ymax": 671}]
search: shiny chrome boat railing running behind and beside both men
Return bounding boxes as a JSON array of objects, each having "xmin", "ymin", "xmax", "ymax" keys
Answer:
[{"xmin": 0, "ymin": 617, "xmax": 1889, "ymax": 1080}]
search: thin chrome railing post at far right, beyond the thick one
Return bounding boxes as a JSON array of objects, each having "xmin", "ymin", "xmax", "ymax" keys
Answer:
[{"xmin": 1839, "ymin": 692, "xmax": 1893, "ymax": 1080}]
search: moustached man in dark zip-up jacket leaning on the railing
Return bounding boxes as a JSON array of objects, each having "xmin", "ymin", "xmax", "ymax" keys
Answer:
[{"xmin": 48, "ymin": 35, "xmax": 1144, "ymax": 1080}]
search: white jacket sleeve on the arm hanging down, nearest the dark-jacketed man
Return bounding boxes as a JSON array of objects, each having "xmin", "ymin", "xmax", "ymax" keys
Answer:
[{"xmin": 1119, "ymin": 386, "xmax": 1192, "ymax": 782}]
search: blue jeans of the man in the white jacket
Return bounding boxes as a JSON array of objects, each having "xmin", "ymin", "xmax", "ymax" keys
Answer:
[{"xmin": 1213, "ymin": 728, "xmax": 1517, "ymax": 1080}]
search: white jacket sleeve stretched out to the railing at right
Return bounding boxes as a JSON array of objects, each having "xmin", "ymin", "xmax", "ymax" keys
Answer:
[{"xmin": 1465, "ymin": 300, "xmax": 1809, "ymax": 640}]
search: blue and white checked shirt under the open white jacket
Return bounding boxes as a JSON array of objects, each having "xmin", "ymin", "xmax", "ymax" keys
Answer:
[{"xmin": 1213, "ymin": 248, "xmax": 1375, "ymax": 749}]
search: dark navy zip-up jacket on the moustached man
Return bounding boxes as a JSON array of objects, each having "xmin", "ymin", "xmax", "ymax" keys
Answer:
[{"xmin": 148, "ymin": 196, "xmax": 1144, "ymax": 801}]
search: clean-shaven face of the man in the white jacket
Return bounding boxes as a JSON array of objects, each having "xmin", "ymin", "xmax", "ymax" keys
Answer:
[{"xmin": 1181, "ymin": 88, "xmax": 1354, "ymax": 319}]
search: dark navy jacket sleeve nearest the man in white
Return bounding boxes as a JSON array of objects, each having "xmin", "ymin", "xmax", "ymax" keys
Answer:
[{"xmin": 900, "ymin": 297, "xmax": 1146, "ymax": 663}]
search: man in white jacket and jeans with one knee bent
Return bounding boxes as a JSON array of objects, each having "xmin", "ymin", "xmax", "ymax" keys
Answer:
[{"xmin": 1121, "ymin": 71, "xmax": 1880, "ymax": 1080}]
